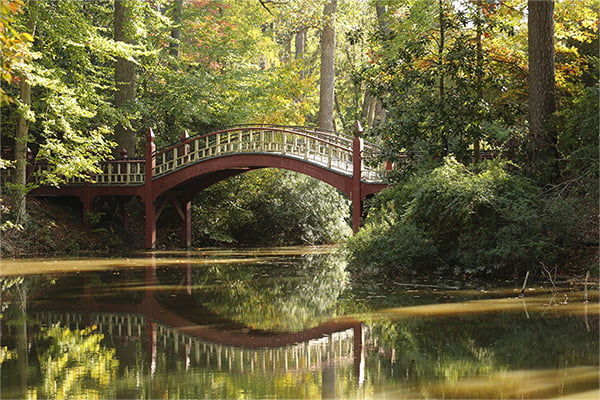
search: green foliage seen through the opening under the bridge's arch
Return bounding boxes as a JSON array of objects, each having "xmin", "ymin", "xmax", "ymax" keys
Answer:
[{"xmin": 193, "ymin": 169, "xmax": 350, "ymax": 245}]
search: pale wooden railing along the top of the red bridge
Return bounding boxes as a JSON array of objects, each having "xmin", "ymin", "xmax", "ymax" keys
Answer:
[{"xmin": 19, "ymin": 125, "xmax": 385, "ymax": 186}]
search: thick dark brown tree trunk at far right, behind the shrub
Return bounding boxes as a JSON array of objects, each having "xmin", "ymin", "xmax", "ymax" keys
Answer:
[{"xmin": 527, "ymin": 0, "xmax": 558, "ymax": 180}]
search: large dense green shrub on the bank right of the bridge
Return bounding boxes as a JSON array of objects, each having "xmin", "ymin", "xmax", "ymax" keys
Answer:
[{"xmin": 347, "ymin": 158, "xmax": 577, "ymax": 273}]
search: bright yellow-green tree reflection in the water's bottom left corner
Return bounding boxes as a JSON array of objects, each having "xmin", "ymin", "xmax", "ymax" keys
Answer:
[{"xmin": 0, "ymin": 276, "xmax": 118, "ymax": 399}]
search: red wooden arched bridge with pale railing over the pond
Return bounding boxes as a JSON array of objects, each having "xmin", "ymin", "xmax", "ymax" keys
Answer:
[{"xmin": 30, "ymin": 125, "xmax": 386, "ymax": 249}]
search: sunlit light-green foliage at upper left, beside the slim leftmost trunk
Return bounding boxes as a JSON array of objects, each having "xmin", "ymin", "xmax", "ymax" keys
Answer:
[{"xmin": 2, "ymin": 1, "xmax": 119, "ymax": 185}]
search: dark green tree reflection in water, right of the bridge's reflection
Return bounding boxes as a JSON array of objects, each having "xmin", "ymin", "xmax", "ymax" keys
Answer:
[{"xmin": 367, "ymin": 313, "xmax": 600, "ymax": 395}]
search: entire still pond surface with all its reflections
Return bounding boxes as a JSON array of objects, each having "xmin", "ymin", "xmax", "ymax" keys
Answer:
[{"xmin": 0, "ymin": 248, "xmax": 600, "ymax": 399}]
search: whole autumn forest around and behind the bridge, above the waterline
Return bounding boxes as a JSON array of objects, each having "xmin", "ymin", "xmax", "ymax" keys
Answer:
[{"xmin": 0, "ymin": 0, "xmax": 600, "ymax": 273}]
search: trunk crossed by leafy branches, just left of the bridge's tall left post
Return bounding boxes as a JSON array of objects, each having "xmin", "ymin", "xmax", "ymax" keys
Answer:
[{"xmin": 113, "ymin": 0, "xmax": 137, "ymax": 158}]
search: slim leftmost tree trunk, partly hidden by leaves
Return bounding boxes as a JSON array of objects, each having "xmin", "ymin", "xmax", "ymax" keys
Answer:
[{"xmin": 14, "ymin": 0, "xmax": 38, "ymax": 223}]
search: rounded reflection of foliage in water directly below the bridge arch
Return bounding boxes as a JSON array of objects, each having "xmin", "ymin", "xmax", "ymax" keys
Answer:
[{"xmin": 188, "ymin": 254, "xmax": 347, "ymax": 332}]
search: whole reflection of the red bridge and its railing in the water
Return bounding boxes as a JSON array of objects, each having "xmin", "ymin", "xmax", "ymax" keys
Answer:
[{"xmin": 31, "ymin": 259, "xmax": 365, "ymax": 385}]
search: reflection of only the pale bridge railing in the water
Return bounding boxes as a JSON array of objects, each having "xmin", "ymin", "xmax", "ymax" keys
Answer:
[{"xmin": 32, "ymin": 311, "xmax": 364, "ymax": 381}]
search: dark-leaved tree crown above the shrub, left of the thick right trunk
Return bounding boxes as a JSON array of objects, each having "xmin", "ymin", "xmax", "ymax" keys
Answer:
[{"xmin": 361, "ymin": 1, "xmax": 524, "ymax": 161}]
